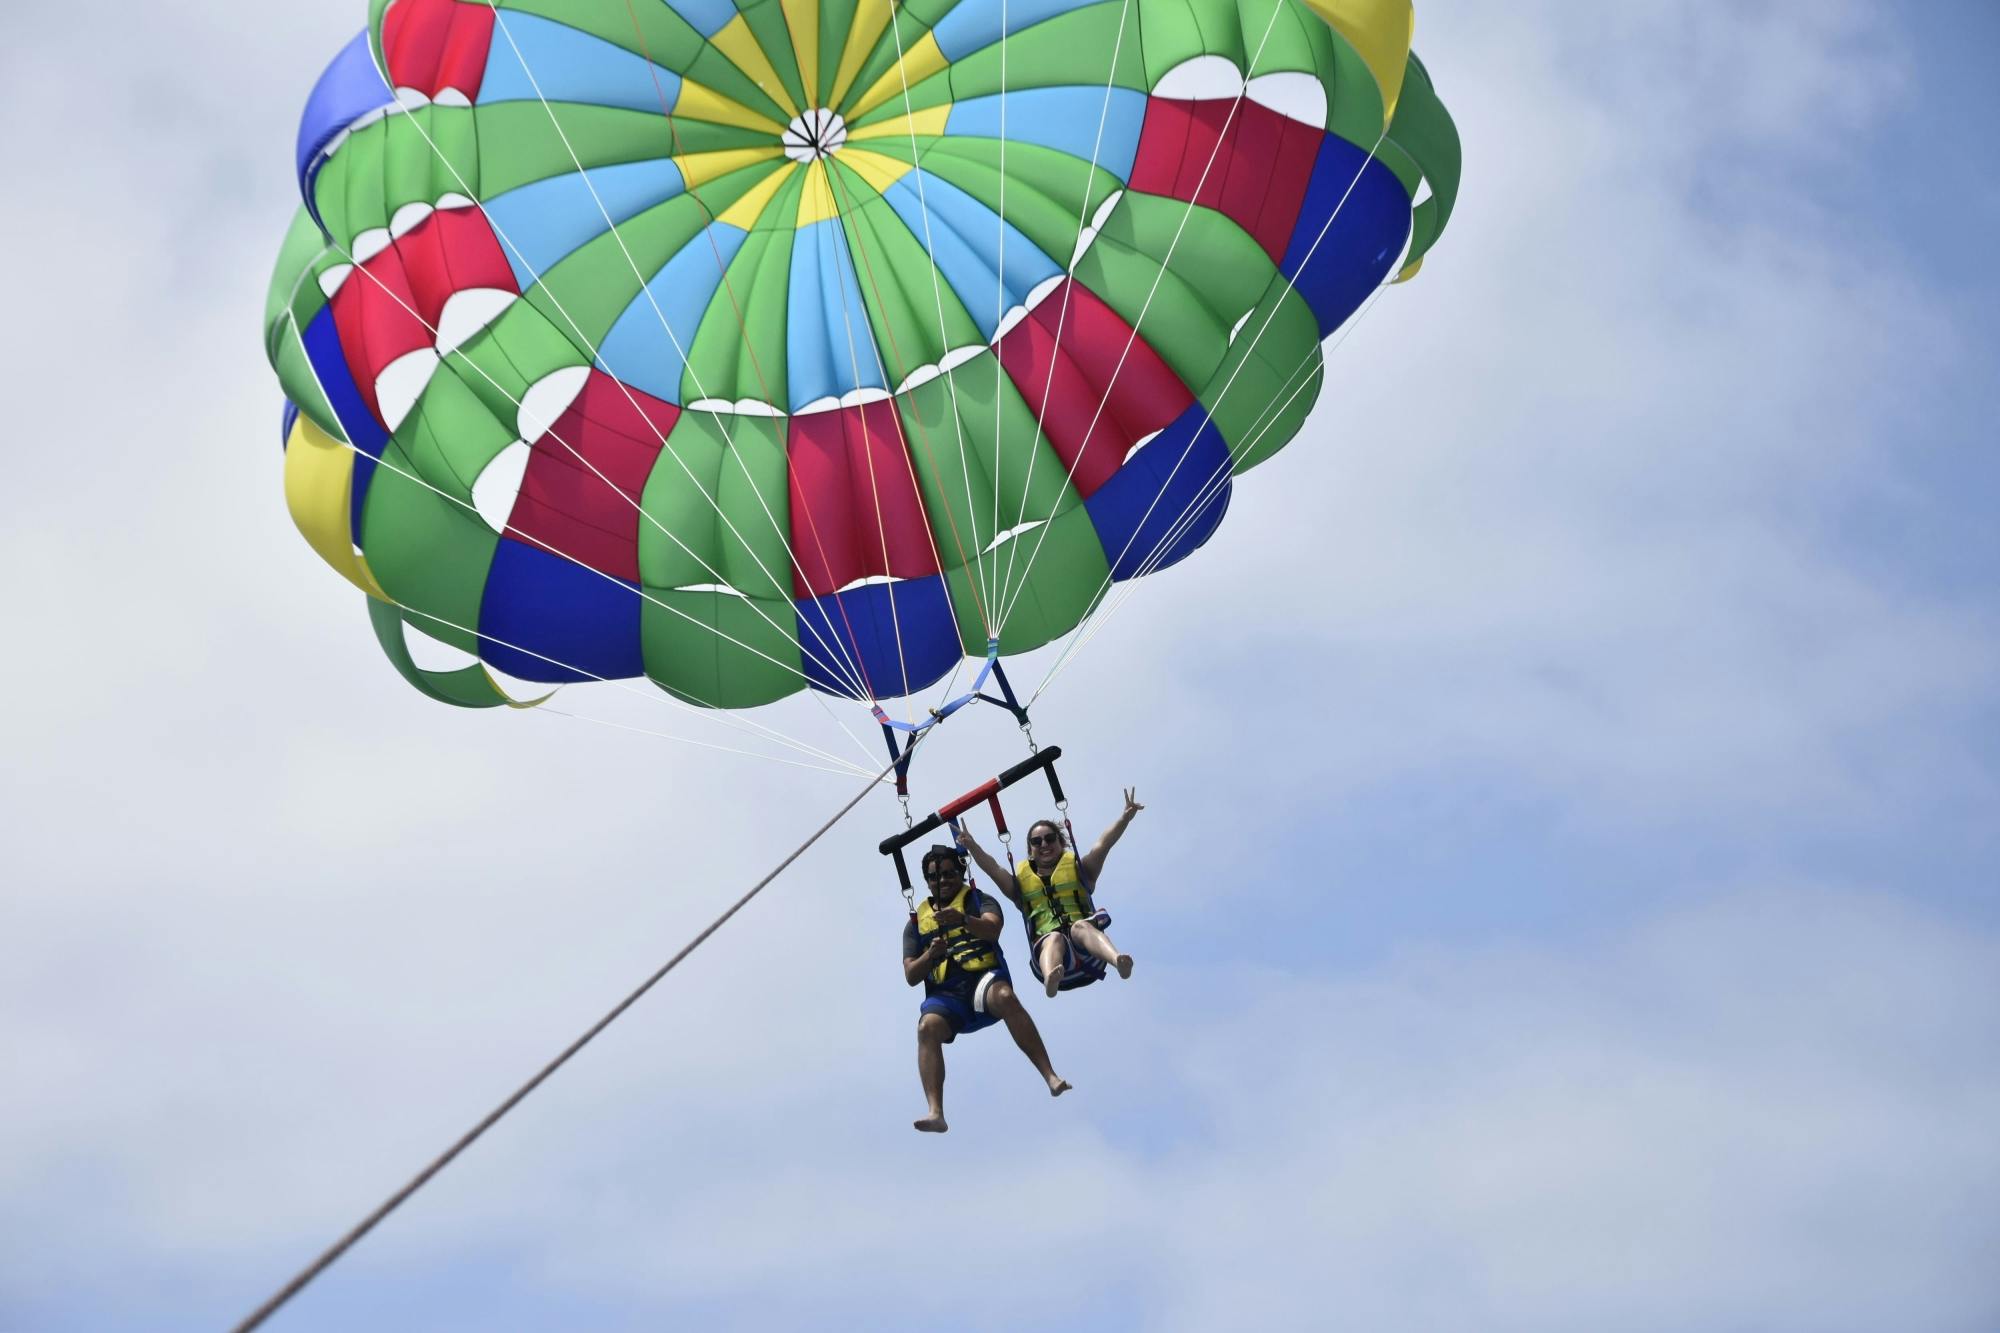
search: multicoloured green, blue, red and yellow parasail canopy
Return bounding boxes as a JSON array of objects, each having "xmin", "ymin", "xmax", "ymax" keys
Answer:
[{"xmin": 266, "ymin": 0, "xmax": 1458, "ymax": 707}]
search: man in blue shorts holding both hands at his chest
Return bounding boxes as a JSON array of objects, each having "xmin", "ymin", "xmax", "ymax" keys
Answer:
[{"xmin": 902, "ymin": 847, "xmax": 1070, "ymax": 1135}]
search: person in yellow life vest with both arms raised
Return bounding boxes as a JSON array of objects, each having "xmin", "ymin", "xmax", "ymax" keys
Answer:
[{"xmin": 960, "ymin": 787, "xmax": 1146, "ymax": 999}]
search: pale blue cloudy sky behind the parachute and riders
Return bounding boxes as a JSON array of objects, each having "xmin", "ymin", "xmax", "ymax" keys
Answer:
[{"xmin": 0, "ymin": 0, "xmax": 2000, "ymax": 1333}]
